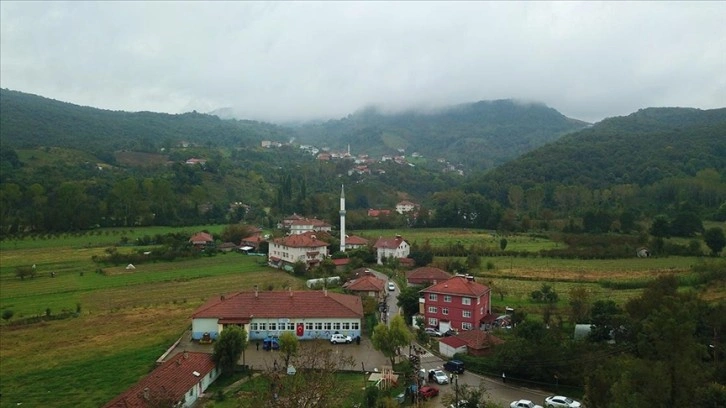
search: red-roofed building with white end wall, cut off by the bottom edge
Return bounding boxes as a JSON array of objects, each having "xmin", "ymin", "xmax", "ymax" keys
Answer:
[{"xmin": 104, "ymin": 351, "xmax": 221, "ymax": 408}]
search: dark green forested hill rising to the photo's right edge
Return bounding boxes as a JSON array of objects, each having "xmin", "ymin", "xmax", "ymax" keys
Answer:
[{"xmin": 475, "ymin": 108, "xmax": 726, "ymax": 189}]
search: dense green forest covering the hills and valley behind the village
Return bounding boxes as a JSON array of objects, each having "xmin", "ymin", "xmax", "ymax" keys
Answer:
[{"xmin": 0, "ymin": 90, "xmax": 726, "ymax": 245}]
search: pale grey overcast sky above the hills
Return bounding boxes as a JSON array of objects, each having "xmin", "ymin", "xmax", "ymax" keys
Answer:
[{"xmin": 0, "ymin": 0, "xmax": 726, "ymax": 122}]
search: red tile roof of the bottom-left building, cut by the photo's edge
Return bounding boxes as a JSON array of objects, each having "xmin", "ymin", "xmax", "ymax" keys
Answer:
[{"xmin": 104, "ymin": 352, "xmax": 214, "ymax": 408}]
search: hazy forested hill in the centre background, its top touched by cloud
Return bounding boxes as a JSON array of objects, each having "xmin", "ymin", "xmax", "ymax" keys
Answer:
[{"xmin": 296, "ymin": 100, "xmax": 587, "ymax": 169}]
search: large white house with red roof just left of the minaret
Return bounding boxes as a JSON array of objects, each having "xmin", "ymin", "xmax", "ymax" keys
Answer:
[{"xmin": 267, "ymin": 232, "xmax": 328, "ymax": 270}]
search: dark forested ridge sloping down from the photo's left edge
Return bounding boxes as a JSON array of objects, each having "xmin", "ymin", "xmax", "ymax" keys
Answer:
[{"xmin": 0, "ymin": 89, "xmax": 289, "ymax": 152}]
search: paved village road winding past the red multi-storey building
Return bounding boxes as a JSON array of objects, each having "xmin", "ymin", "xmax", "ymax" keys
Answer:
[{"xmin": 370, "ymin": 269, "xmax": 551, "ymax": 407}]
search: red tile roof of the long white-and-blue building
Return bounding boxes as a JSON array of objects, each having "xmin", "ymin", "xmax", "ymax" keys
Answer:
[{"xmin": 192, "ymin": 291, "xmax": 363, "ymax": 321}]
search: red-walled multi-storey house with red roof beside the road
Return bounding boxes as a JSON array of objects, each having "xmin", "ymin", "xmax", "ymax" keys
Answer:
[{"xmin": 419, "ymin": 275, "xmax": 492, "ymax": 332}]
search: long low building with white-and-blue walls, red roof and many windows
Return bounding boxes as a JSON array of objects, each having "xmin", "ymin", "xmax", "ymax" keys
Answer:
[{"xmin": 192, "ymin": 290, "xmax": 363, "ymax": 340}]
